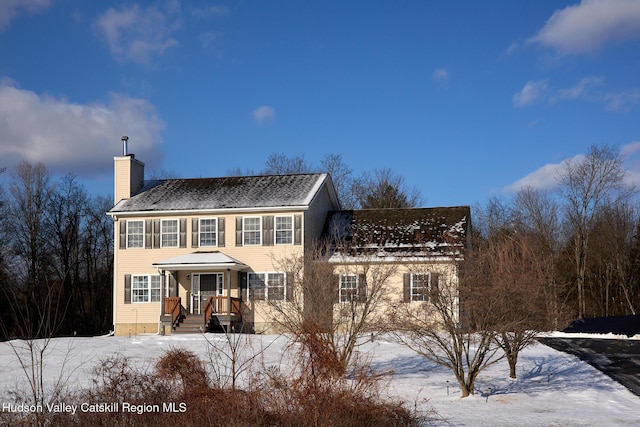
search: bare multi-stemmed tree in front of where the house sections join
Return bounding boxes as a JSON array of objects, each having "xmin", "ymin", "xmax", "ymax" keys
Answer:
[{"xmin": 269, "ymin": 242, "xmax": 397, "ymax": 377}]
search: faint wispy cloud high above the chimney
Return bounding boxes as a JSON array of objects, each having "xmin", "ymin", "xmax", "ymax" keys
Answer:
[{"xmin": 94, "ymin": 4, "xmax": 182, "ymax": 64}]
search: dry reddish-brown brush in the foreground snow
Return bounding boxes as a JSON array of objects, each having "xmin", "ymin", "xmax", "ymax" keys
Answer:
[{"xmin": 0, "ymin": 344, "xmax": 421, "ymax": 427}]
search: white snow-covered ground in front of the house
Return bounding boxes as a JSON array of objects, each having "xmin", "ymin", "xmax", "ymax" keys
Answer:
[{"xmin": 0, "ymin": 334, "xmax": 640, "ymax": 426}]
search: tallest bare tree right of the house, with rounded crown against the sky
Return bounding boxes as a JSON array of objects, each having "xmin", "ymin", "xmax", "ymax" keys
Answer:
[{"xmin": 557, "ymin": 145, "xmax": 635, "ymax": 318}]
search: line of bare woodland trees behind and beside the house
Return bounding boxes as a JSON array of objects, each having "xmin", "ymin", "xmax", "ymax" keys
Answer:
[{"xmin": 0, "ymin": 146, "xmax": 640, "ymax": 338}]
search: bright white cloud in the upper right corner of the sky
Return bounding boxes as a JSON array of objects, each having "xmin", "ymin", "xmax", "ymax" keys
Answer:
[{"xmin": 529, "ymin": 0, "xmax": 640, "ymax": 54}]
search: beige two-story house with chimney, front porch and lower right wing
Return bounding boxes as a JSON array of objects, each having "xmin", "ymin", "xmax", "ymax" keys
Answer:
[{"xmin": 107, "ymin": 150, "xmax": 469, "ymax": 335}]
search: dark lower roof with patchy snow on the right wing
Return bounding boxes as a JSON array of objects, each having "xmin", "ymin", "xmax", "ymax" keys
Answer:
[{"xmin": 325, "ymin": 206, "xmax": 471, "ymax": 255}]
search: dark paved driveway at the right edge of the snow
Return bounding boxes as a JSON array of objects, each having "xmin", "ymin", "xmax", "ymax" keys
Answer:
[{"xmin": 539, "ymin": 337, "xmax": 640, "ymax": 396}]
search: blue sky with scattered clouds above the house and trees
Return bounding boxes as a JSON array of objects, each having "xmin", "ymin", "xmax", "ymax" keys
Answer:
[{"xmin": 0, "ymin": 0, "xmax": 640, "ymax": 206}]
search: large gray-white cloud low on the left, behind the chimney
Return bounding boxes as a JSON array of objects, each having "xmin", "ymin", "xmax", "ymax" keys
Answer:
[{"xmin": 0, "ymin": 80, "xmax": 164, "ymax": 178}]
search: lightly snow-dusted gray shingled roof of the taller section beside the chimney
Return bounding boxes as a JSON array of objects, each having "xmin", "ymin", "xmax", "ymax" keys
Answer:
[{"xmin": 109, "ymin": 174, "xmax": 327, "ymax": 213}]
